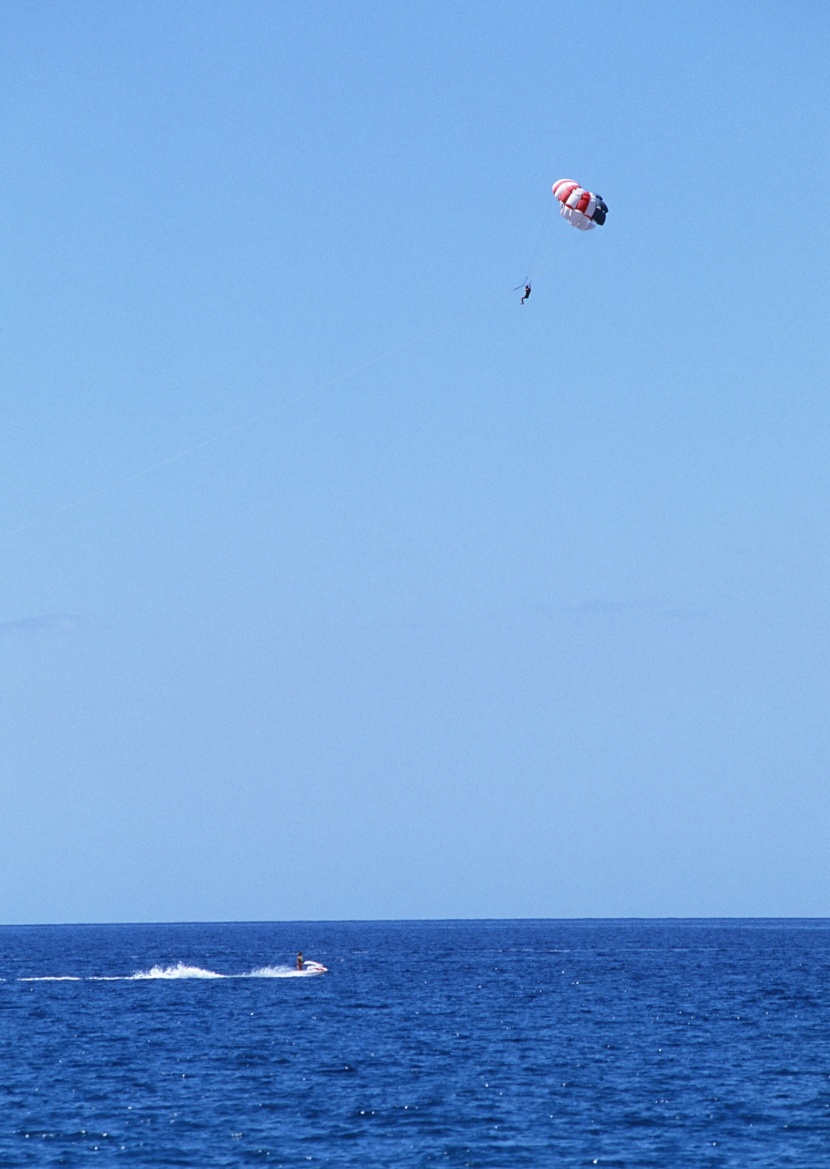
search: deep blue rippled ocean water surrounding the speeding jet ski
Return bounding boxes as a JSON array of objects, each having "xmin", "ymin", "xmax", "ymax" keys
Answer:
[{"xmin": 0, "ymin": 920, "xmax": 830, "ymax": 1169}]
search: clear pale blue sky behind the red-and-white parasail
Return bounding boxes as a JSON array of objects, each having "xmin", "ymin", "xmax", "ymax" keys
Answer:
[{"xmin": 0, "ymin": 0, "xmax": 830, "ymax": 922}]
